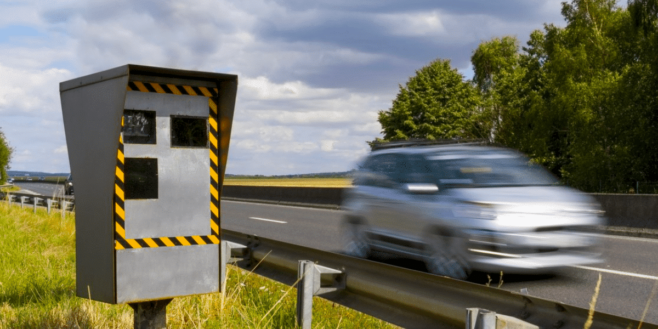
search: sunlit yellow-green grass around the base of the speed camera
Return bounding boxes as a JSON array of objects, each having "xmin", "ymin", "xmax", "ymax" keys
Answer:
[{"xmin": 0, "ymin": 202, "xmax": 394, "ymax": 329}]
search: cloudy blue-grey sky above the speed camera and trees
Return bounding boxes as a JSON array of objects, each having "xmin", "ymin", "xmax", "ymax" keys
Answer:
[{"xmin": 0, "ymin": 0, "xmax": 564, "ymax": 175}]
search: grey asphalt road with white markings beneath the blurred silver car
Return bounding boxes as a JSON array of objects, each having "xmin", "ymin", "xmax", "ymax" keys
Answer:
[{"xmin": 221, "ymin": 201, "xmax": 658, "ymax": 327}]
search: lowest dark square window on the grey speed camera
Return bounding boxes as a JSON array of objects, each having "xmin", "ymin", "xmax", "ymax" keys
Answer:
[{"xmin": 123, "ymin": 158, "xmax": 158, "ymax": 200}]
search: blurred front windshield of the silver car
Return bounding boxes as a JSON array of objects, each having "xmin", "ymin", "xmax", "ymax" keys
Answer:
[{"xmin": 426, "ymin": 152, "xmax": 557, "ymax": 186}]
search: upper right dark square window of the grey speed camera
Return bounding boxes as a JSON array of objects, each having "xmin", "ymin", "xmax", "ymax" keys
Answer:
[{"xmin": 171, "ymin": 116, "xmax": 208, "ymax": 147}]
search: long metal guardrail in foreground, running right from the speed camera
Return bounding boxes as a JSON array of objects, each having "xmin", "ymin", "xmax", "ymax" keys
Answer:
[{"xmin": 222, "ymin": 230, "xmax": 638, "ymax": 329}]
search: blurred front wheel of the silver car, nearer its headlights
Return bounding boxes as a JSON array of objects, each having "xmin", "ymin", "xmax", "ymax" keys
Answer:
[{"xmin": 425, "ymin": 235, "xmax": 471, "ymax": 280}]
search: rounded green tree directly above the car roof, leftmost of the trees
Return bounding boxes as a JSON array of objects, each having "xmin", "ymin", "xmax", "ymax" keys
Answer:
[{"xmin": 377, "ymin": 59, "xmax": 488, "ymax": 141}]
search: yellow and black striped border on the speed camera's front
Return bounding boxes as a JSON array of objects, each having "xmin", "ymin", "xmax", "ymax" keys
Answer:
[{"xmin": 114, "ymin": 81, "xmax": 220, "ymax": 250}]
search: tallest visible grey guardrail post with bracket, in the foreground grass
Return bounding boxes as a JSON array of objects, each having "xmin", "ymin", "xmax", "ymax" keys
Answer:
[{"xmin": 297, "ymin": 260, "xmax": 345, "ymax": 329}]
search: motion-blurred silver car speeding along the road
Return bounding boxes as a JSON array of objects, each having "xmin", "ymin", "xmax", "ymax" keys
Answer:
[{"xmin": 342, "ymin": 143, "xmax": 605, "ymax": 279}]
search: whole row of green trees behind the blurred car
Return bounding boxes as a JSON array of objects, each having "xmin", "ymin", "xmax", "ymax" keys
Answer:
[{"xmin": 378, "ymin": 0, "xmax": 658, "ymax": 192}]
